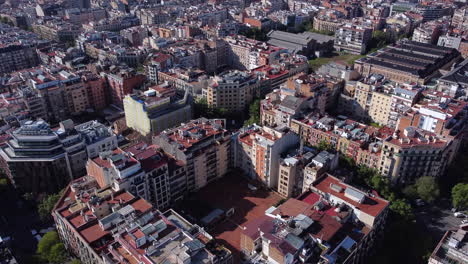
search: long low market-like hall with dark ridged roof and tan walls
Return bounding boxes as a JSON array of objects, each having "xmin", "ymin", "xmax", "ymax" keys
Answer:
[{"xmin": 354, "ymin": 40, "xmax": 460, "ymax": 84}]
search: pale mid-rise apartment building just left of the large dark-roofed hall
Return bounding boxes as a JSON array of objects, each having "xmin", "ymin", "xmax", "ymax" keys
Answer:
[{"xmin": 334, "ymin": 24, "xmax": 372, "ymax": 54}]
